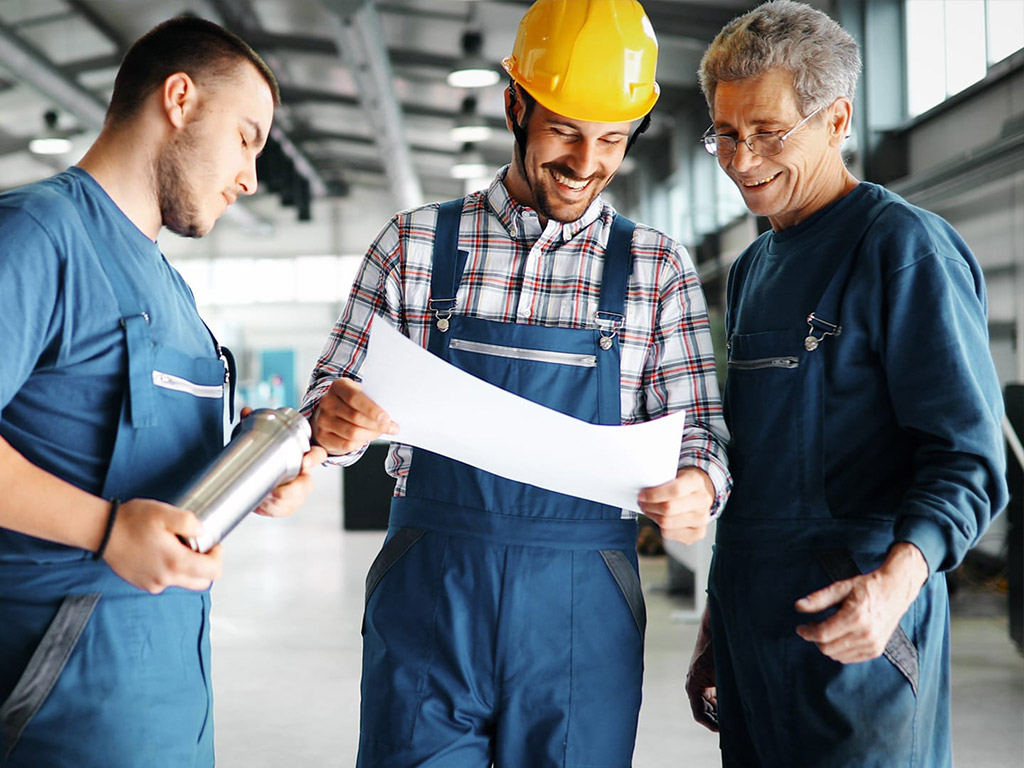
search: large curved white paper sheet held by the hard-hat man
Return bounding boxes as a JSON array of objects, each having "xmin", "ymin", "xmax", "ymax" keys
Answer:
[{"xmin": 359, "ymin": 322, "xmax": 685, "ymax": 511}]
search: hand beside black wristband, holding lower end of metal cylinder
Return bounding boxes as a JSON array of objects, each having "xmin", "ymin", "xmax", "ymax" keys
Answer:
[{"xmin": 103, "ymin": 499, "xmax": 220, "ymax": 595}]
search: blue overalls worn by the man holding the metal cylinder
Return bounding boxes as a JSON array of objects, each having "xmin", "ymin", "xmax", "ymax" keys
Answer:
[{"xmin": 0, "ymin": 188, "xmax": 225, "ymax": 768}]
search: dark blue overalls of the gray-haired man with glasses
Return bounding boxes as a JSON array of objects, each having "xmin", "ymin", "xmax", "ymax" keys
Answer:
[{"xmin": 709, "ymin": 195, "xmax": 951, "ymax": 768}]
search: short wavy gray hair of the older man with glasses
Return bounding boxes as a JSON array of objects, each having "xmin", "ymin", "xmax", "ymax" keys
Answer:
[{"xmin": 698, "ymin": 0, "xmax": 860, "ymax": 115}]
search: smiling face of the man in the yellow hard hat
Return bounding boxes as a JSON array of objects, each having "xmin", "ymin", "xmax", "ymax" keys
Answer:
[{"xmin": 506, "ymin": 92, "xmax": 631, "ymax": 223}]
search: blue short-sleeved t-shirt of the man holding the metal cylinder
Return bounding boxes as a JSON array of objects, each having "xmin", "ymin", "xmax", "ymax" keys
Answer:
[{"xmin": 0, "ymin": 168, "xmax": 216, "ymax": 557}]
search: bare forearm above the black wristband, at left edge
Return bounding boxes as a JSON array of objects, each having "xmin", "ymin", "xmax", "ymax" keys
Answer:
[{"xmin": 0, "ymin": 438, "xmax": 110, "ymax": 551}]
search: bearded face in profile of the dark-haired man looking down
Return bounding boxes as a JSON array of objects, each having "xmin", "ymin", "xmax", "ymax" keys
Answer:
[{"xmin": 156, "ymin": 62, "xmax": 273, "ymax": 238}]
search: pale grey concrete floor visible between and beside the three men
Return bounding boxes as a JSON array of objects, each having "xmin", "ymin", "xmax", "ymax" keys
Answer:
[{"xmin": 212, "ymin": 468, "xmax": 1024, "ymax": 768}]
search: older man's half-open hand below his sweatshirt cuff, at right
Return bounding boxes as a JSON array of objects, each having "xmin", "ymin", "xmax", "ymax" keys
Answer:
[{"xmin": 797, "ymin": 542, "xmax": 928, "ymax": 664}]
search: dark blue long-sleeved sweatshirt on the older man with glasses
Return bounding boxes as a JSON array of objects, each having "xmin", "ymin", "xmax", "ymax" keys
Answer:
[{"xmin": 725, "ymin": 183, "xmax": 1007, "ymax": 570}]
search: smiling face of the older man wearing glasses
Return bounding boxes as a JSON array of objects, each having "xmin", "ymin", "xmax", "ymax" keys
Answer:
[{"xmin": 713, "ymin": 70, "xmax": 856, "ymax": 231}]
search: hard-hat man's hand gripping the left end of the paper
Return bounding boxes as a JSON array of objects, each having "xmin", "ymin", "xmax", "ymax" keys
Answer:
[{"xmin": 309, "ymin": 378, "xmax": 398, "ymax": 456}]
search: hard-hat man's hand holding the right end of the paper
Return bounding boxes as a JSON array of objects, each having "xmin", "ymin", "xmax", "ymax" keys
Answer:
[{"xmin": 638, "ymin": 467, "xmax": 715, "ymax": 544}]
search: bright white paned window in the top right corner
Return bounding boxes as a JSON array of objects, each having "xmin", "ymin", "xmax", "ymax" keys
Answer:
[{"xmin": 905, "ymin": 0, "xmax": 1024, "ymax": 117}]
